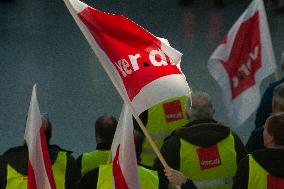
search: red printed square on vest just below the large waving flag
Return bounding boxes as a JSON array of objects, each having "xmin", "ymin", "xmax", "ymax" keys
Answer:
[{"xmin": 163, "ymin": 100, "xmax": 184, "ymax": 123}]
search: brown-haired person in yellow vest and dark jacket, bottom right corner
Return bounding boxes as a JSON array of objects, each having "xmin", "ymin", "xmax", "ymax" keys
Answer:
[{"xmin": 233, "ymin": 112, "xmax": 284, "ymax": 189}]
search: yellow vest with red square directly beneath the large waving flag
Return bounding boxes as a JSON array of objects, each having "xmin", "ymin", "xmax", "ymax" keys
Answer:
[{"xmin": 140, "ymin": 96, "xmax": 188, "ymax": 166}]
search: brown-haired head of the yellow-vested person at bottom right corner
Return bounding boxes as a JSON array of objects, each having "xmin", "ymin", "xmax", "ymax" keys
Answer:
[{"xmin": 263, "ymin": 112, "xmax": 284, "ymax": 148}]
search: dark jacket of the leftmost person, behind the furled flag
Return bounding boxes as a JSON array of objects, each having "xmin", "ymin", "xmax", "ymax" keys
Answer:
[{"xmin": 0, "ymin": 145, "xmax": 80, "ymax": 189}]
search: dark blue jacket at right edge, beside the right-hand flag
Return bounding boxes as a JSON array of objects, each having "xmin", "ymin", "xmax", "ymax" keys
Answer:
[{"xmin": 254, "ymin": 77, "xmax": 284, "ymax": 128}]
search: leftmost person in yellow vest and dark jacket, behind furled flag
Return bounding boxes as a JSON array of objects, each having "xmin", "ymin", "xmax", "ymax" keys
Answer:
[{"xmin": 0, "ymin": 113, "xmax": 80, "ymax": 189}]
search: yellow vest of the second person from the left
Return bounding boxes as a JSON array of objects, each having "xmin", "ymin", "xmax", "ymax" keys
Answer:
[{"xmin": 81, "ymin": 150, "xmax": 110, "ymax": 176}]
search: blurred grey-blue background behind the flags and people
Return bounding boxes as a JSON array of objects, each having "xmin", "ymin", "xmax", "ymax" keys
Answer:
[{"xmin": 0, "ymin": 0, "xmax": 284, "ymax": 156}]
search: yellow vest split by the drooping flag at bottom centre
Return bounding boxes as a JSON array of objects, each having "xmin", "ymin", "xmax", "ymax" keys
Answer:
[{"xmin": 97, "ymin": 164, "xmax": 159, "ymax": 189}]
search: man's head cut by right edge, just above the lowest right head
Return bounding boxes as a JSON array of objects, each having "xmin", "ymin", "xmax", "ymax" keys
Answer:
[{"xmin": 272, "ymin": 83, "xmax": 284, "ymax": 112}]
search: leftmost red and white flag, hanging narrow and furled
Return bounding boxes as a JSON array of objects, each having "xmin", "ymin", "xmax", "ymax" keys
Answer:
[{"xmin": 24, "ymin": 85, "xmax": 56, "ymax": 189}]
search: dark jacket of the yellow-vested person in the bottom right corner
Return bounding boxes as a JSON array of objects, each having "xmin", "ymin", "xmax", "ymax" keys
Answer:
[{"xmin": 233, "ymin": 149, "xmax": 284, "ymax": 189}]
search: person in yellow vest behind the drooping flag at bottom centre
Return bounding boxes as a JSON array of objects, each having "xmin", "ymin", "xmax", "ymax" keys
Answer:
[{"xmin": 79, "ymin": 130, "xmax": 159, "ymax": 189}]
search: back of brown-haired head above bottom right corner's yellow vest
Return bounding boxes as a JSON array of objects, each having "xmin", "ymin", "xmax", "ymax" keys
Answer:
[{"xmin": 266, "ymin": 112, "xmax": 284, "ymax": 147}]
